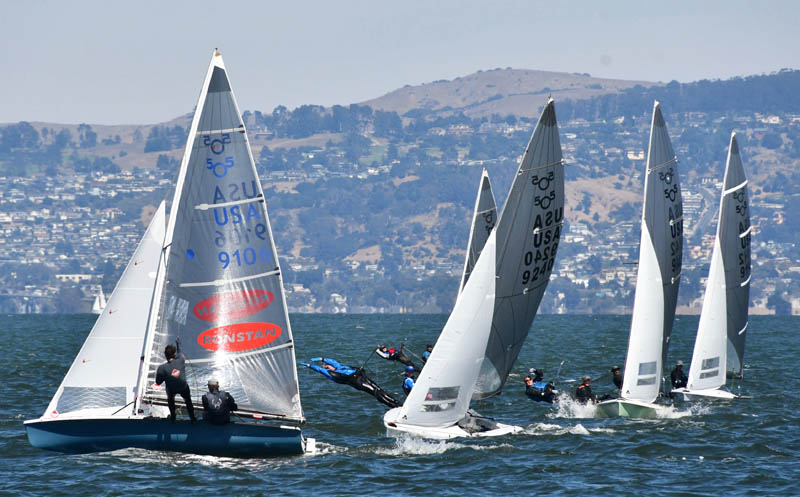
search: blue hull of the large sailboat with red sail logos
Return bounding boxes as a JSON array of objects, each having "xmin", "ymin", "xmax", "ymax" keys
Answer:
[{"xmin": 25, "ymin": 418, "xmax": 305, "ymax": 457}]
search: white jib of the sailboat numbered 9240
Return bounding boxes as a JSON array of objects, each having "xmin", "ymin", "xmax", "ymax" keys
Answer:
[{"xmin": 397, "ymin": 232, "xmax": 497, "ymax": 427}]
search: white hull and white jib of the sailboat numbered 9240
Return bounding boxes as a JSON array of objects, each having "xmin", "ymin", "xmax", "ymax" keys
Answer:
[{"xmin": 383, "ymin": 232, "xmax": 522, "ymax": 440}]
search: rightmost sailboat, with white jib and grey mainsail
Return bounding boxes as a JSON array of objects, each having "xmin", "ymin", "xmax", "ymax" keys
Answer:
[{"xmin": 672, "ymin": 133, "xmax": 751, "ymax": 400}]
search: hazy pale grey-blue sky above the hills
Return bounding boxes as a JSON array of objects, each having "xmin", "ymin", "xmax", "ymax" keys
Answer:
[{"xmin": 0, "ymin": 0, "xmax": 800, "ymax": 124}]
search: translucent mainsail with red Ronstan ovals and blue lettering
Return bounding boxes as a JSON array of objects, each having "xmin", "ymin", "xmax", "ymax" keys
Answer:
[{"xmin": 138, "ymin": 52, "xmax": 303, "ymax": 422}]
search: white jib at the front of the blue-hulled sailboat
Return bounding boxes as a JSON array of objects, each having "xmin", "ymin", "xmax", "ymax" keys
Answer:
[{"xmin": 43, "ymin": 202, "xmax": 165, "ymax": 419}]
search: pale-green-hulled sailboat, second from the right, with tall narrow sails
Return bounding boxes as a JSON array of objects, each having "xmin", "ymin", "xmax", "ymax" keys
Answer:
[{"xmin": 597, "ymin": 101, "xmax": 683, "ymax": 418}]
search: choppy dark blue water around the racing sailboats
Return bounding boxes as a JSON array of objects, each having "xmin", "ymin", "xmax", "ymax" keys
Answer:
[{"xmin": 0, "ymin": 315, "xmax": 800, "ymax": 496}]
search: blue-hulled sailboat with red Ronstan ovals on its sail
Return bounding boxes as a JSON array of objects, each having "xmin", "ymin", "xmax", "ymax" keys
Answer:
[{"xmin": 25, "ymin": 50, "xmax": 315, "ymax": 457}]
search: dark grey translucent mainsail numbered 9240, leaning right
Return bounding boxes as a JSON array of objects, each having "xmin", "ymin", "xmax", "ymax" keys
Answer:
[{"xmin": 473, "ymin": 98, "xmax": 564, "ymax": 398}]
